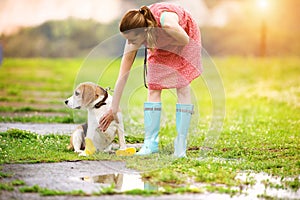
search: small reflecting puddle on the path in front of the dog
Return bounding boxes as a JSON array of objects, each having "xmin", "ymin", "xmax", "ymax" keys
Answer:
[{"xmin": 81, "ymin": 173, "xmax": 158, "ymax": 192}]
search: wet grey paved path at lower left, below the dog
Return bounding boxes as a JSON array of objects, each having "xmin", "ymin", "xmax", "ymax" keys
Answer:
[{"xmin": 2, "ymin": 161, "xmax": 138, "ymax": 194}]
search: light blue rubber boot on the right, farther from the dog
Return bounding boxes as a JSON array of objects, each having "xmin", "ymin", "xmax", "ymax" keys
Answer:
[{"xmin": 174, "ymin": 104, "xmax": 194, "ymax": 158}]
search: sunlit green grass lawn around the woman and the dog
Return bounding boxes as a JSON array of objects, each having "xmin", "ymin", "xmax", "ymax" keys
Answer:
[{"xmin": 0, "ymin": 57, "xmax": 300, "ymax": 198}]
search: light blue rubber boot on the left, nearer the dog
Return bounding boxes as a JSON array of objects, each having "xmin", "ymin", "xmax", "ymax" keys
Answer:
[{"xmin": 135, "ymin": 102, "xmax": 161, "ymax": 156}]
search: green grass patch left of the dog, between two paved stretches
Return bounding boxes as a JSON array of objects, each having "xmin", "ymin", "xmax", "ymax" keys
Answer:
[{"xmin": 0, "ymin": 129, "xmax": 78, "ymax": 164}]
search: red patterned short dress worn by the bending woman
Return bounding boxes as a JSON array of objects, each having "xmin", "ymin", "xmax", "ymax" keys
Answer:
[{"xmin": 147, "ymin": 3, "xmax": 202, "ymax": 90}]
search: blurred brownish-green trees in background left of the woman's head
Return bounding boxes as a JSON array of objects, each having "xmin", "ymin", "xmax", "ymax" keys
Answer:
[{"xmin": 3, "ymin": 18, "xmax": 118, "ymax": 57}]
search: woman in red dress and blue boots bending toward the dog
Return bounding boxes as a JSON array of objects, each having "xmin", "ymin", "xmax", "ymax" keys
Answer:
[{"xmin": 100, "ymin": 3, "xmax": 201, "ymax": 157}]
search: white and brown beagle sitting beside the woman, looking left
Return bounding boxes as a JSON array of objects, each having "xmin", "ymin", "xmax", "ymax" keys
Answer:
[{"xmin": 65, "ymin": 82, "xmax": 126, "ymax": 156}]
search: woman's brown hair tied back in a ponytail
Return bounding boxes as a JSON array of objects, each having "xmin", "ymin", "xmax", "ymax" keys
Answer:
[{"xmin": 119, "ymin": 6, "xmax": 158, "ymax": 48}]
